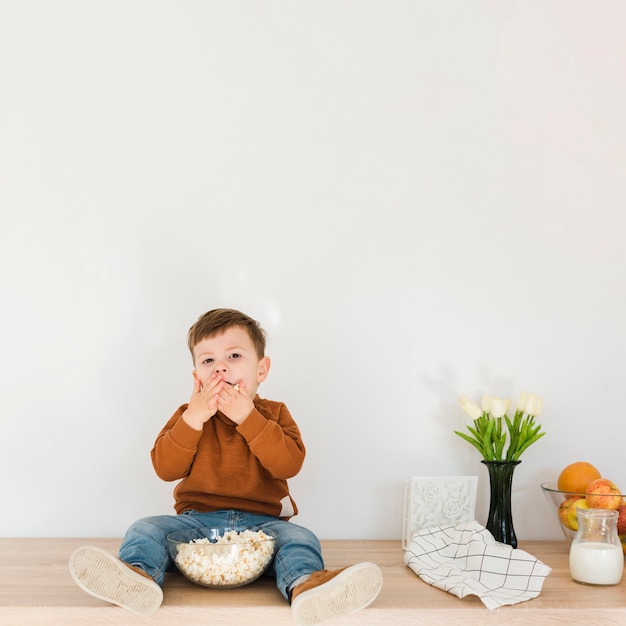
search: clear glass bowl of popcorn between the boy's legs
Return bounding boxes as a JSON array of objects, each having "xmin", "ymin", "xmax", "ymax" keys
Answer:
[{"xmin": 167, "ymin": 528, "xmax": 276, "ymax": 589}]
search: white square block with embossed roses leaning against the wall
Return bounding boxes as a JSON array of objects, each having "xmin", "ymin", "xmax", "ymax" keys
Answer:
[{"xmin": 402, "ymin": 476, "xmax": 478, "ymax": 550}]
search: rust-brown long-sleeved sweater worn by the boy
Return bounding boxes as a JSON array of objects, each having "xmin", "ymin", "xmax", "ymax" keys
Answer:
[{"xmin": 151, "ymin": 395, "xmax": 305, "ymax": 519}]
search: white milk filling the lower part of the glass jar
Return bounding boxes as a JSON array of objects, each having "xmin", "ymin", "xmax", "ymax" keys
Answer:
[{"xmin": 569, "ymin": 541, "xmax": 624, "ymax": 585}]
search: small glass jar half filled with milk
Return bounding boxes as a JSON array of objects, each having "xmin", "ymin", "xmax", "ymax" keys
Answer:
[{"xmin": 569, "ymin": 507, "xmax": 624, "ymax": 585}]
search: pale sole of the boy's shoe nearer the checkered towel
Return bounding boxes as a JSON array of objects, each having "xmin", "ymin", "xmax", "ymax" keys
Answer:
[{"xmin": 291, "ymin": 563, "xmax": 383, "ymax": 626}]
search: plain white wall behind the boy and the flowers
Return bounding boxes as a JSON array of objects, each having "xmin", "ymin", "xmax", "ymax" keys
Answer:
[{"xmin": 0, "ymin": 0, "xmax": 626, "ymax": 539}]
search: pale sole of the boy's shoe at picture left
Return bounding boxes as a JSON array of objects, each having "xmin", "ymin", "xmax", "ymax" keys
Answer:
[{"xmin": 70, "ymin": 546, "xmax": 163, "ymax": 615}]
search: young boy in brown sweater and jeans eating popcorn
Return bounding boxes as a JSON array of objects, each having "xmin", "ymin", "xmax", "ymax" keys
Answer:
[{"xmin": 70, "ymin": 309, "xmax": 382, "ymax": 624}]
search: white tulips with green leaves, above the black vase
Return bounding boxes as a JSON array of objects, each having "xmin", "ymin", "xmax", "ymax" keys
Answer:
[{"xmin": 454, "ymin": 391, "xmax": 545, "ymax": 461}]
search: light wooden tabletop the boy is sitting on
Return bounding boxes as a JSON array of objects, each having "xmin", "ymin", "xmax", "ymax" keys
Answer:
[{"xmin": 0, "ymin": 538, "xmax": 626, "ymax": 626}]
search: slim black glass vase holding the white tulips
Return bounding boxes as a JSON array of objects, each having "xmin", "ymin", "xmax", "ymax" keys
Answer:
[{"xmin": 481, "ymin": 460, "xmax": 521, "ymax": 548}]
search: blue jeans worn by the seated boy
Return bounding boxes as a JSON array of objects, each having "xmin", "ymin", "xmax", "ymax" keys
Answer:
[{"xmin": 119, "ymin": 510, "xmax": 324, "ymax": 600}]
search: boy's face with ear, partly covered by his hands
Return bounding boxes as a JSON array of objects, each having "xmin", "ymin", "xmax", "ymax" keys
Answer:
[{"xmin": 193, "ymin": 326, "xmax": 270, "ymax": 398}]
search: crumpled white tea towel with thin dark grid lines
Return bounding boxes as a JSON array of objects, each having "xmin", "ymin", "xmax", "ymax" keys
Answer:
[{"xmin": 404, "ymin": 521, "xmax": 552, "ymax": 609}]
